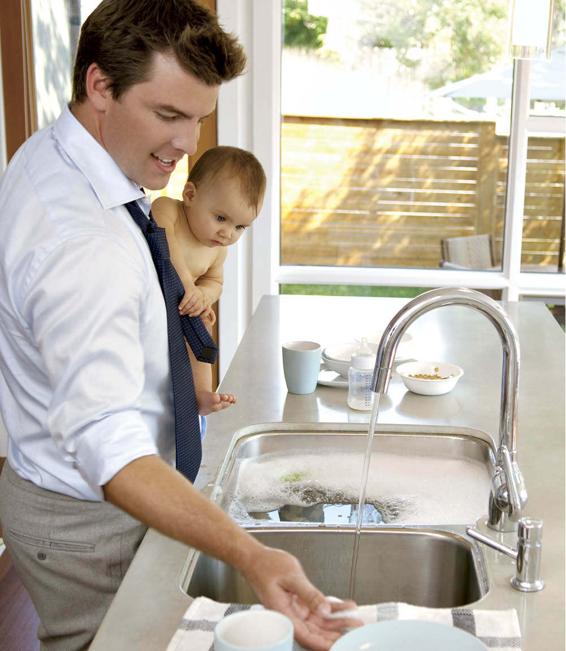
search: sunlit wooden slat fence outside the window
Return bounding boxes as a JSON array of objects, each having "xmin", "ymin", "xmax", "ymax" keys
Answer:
[{"xmin": 281, "ymin": 117, "xmax": 564, "ymax": 267}]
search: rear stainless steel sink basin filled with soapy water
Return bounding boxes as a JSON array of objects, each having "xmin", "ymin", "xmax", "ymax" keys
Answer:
[{"xmin": 212, "ymin": 423, "xmax": 494, "ymax": 528}]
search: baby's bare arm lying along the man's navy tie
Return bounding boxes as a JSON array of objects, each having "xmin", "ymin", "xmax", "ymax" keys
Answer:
[{"xmin": 151, "ymin": 197, "xmax": 203, "ymax": 316}]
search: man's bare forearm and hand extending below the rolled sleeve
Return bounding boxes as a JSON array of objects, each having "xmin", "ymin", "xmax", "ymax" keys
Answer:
[{"xmin": 103, "ymin": 455, "xmax": 359, "ymax": 650}]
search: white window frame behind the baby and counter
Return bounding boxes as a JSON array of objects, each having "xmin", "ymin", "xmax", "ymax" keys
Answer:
[{"xmin": 222, "ymin": 0, "xmax": 566, "ymax": 371}]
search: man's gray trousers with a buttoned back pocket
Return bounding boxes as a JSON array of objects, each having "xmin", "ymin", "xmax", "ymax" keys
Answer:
[{"xmin": 0, "ymin": 463, "xmax": 146, "ymax": 651}]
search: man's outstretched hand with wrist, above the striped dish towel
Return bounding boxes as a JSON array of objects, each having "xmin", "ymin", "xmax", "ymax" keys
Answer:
[{"xmin": 243, "ymin": 547, "xmax": 362, "ymax": 651}]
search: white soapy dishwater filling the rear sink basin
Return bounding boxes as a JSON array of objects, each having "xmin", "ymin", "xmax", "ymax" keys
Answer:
[{"xmin": 229, "ymin": 451, "xmax": 490, "ymax": 525}]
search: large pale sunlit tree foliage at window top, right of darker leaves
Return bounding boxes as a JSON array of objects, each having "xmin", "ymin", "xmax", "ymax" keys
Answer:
[{"xmin": 362, "ymin": 0, "xmax": 508, "ymax": 88}]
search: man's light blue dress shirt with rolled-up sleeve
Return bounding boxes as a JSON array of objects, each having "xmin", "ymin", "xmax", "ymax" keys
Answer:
[{"xmin": 0, "ymin": 109, "xmax": 175, "ymax": 500}]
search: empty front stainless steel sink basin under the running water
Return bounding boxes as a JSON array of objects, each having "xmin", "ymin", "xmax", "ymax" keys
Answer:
[{"xmin": 181, "ymin": 527, "xmax": 488, "ymax": 608}]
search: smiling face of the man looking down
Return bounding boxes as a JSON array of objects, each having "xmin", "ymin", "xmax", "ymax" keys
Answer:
[{"xmin": 98, "ymin": 53, "xmax": 219, "ymax": 190}]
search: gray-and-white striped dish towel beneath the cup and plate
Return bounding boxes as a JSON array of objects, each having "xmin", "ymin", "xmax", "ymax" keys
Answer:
[{"xmin": 167, "ymin": 597, "xmax": 521, "ymax": 651}]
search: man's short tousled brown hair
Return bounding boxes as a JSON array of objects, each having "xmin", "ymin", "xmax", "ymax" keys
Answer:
[{"xmin": 73, "ymin": 0, "xmax": 246, "ymax": 103}]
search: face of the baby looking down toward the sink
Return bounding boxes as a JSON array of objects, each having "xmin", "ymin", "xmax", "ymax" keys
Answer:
[{"xmin": 183, "ymin": 176, "xmax": 261, "ymax": 247}]
